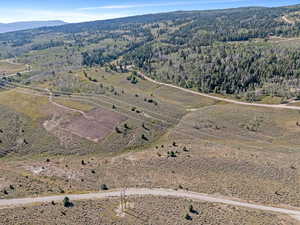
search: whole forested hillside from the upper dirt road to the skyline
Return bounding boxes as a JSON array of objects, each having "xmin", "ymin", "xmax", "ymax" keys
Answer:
[{"xmin": 0, "ymin": 5, "xmax": 300, "ymax": 100}]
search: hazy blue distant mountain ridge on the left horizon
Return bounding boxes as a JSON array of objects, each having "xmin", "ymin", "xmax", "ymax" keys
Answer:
[{"xmin": 0, "ymin": 20, "xmax": 67, "ymax": 33}]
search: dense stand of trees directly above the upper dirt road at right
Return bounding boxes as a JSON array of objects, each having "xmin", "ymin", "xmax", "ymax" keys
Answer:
[{"xmin": 127, "ymin": 43, "xmax": 300, "ymax": 97}]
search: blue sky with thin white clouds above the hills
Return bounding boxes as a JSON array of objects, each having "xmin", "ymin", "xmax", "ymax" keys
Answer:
[{"xmin": 0, "ymin": 0, "xmax": 300, "ymax": 23}]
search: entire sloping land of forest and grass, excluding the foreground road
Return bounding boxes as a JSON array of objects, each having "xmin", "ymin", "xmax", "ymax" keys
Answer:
[{"xmin": 0, "ymin": 5, "xmax": 300, "ymax": 225}]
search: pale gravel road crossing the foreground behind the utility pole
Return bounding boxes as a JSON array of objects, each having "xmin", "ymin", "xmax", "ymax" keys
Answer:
[{"xmin": 0, "ymin": 188, "xmax": 300, "ymax": 221}]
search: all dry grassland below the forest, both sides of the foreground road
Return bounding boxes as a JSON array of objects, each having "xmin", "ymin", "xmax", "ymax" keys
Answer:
[{"xmin": 0, "ymin": 63, "xmax": 300, "ymax": 224}]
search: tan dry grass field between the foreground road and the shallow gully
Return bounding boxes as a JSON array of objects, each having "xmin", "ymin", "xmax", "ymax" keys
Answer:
[{"xmin": 1, "ymin": 104, "xmax": 300, "ymax": 210}]
